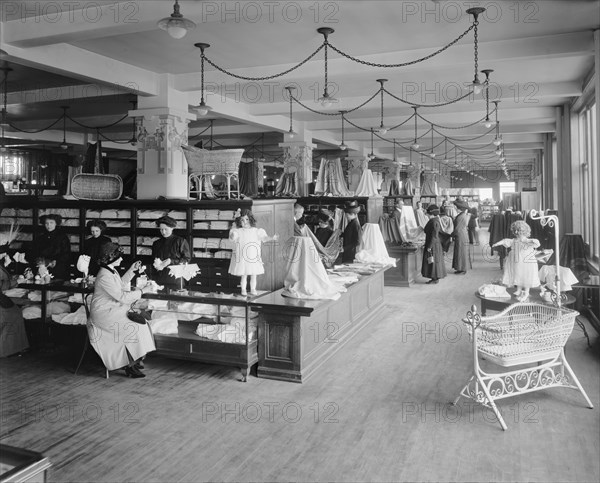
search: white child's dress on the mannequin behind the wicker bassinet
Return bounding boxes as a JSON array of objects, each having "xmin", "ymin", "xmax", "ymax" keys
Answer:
[{"xmin": 499, "ymin": 238, "xmax": 540, "ymax": 288}]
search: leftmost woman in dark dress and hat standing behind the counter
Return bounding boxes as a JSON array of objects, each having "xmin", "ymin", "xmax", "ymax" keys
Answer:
[{"xmin": 27, "ymin": 214, "xmax": 71, "ymax": 280}]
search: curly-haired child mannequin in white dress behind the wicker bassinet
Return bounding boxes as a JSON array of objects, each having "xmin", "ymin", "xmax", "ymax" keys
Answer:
[{"xmin": 492, "ymin": 221, "xmax": 540, "ymax": 302}]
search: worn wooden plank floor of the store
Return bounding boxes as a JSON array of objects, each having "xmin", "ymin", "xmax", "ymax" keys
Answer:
[{"xmin": 0, "ymin": 229, "xmax": 600, "ymax": 482}]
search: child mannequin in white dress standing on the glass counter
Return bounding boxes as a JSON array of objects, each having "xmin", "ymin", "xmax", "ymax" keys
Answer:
[{"xmin": 229, "ymin": 210, "xmax": 279, "ymax": 296}]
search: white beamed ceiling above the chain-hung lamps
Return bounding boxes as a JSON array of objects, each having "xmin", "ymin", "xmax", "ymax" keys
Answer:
[{"xmin": 0, "ymin": 0, "xmax": 600, "ymax": 174}]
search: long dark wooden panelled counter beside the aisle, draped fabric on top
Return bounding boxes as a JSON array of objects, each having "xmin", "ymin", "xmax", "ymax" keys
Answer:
[{"xmin": 250, "ymin": 269, "xmax": 386, "ymax": 383}]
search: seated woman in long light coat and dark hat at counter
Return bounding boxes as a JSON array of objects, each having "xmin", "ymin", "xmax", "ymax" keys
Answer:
[{"xmin": 88, "ymin": 243, "xmax": 156, "ymax": 378}]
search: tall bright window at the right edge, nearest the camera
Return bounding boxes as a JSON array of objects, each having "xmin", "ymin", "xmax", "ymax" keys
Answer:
[{"xmin": 579, "ymin": 101, "xmax": 600, "ymax": 261}]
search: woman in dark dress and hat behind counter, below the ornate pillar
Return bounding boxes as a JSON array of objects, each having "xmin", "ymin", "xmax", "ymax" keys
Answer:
[{"xmin": 152, "ymin": 216, "xmax": 192, "ymax": 285}]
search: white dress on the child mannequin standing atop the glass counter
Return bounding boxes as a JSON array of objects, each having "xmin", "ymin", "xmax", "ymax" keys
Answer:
[{"xmin": 229, "ymin": 227, "xmax": 268, "ymax": 276}]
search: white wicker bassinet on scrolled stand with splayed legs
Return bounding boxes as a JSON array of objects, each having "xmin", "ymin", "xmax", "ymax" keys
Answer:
[{"xmin": 454, "ymin": 303, "xmax": 594, "ymax": 430}]
